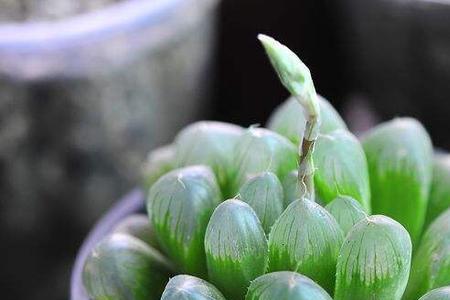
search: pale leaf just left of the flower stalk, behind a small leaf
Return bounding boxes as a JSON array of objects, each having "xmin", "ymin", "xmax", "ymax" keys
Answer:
[{"xmin": 231, "ymin": 127, "xmax": 297, "ymax": 194}]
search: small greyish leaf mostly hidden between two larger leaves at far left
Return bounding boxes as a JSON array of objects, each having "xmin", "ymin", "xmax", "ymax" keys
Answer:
[{"xmin": 113, "ymin": 214, "xmax": 160, "ymax": 250}]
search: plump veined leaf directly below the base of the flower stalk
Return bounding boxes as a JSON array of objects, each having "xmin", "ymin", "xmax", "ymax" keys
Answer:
[{"xmin": 269, "ymin": 199, "xmax": 343, "ymax": 292}]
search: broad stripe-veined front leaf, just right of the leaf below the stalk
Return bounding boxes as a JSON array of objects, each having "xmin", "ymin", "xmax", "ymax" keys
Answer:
[{"xmin": 334, "ymin": 215, "xmax": 412, "ymax": 300}]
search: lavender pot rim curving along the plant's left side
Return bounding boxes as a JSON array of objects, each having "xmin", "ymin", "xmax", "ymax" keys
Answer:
[{"xmin": 70, "ymin": 189, "xmax": 144, "ymax": 300}]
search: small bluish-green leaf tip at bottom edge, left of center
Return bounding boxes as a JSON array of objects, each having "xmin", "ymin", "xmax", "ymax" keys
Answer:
[{"xmin": 161, "ymin": 275, "xmax": 225, "ymax": 300}]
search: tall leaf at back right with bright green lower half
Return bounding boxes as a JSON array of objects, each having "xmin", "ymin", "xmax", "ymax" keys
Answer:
[{"xmin": 363, "ymin": 118, "xmax": 433, "ymax": 244}]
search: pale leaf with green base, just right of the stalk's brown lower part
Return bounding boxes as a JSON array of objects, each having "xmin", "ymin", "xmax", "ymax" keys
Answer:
[{"xmin": 313, "ymin": 129, "xmax": 370, "ymax": 213}]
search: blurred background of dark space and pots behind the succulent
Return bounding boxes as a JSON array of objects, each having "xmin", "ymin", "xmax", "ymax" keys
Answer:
[{"xmin": 0, "ymin": 0, "xmax": 450, "ymax": 299}]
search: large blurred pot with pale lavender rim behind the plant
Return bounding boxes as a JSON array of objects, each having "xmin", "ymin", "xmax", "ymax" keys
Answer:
[{"xmin": 0, "ymin": 0, "xmax": 218, "ymax": 299}]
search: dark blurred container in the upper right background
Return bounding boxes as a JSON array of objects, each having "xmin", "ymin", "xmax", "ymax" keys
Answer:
[{"xmin": 340, "ymin": 0, "xmax": 450, "ymax": 149}]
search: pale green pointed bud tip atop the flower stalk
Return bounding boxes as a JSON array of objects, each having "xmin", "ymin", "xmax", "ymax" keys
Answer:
[{"xmin": 258, "ymin": 34, "xmax": 319, "ymax": 116}]
